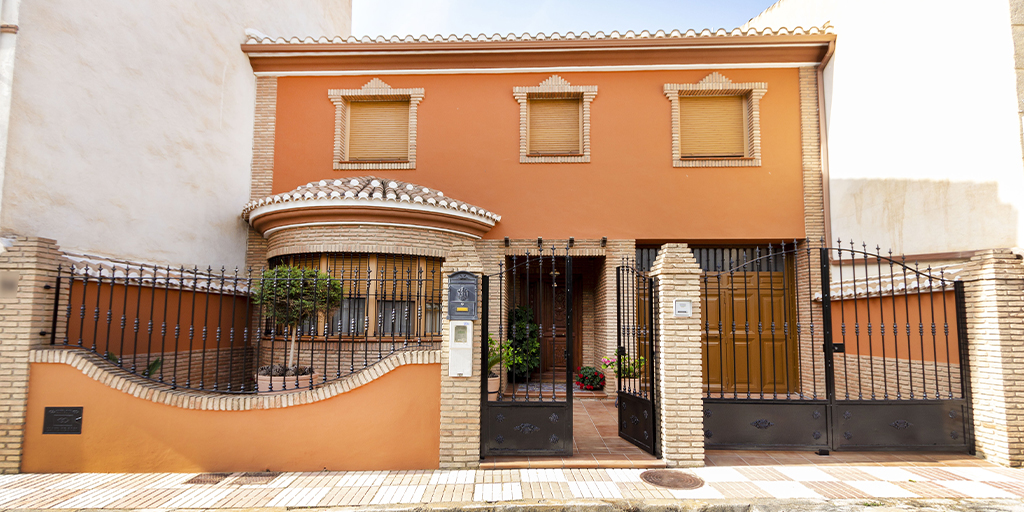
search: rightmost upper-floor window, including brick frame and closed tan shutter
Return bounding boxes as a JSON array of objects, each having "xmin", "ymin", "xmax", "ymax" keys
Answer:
[{"xmin": 665, "ymin": 73, "xmax": 768, "ymax": 167}]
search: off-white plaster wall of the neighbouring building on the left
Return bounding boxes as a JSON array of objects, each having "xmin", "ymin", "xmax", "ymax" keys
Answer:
[{"xmin": 0, "ymin": 0, "xmax": 351, "ymax": 266}]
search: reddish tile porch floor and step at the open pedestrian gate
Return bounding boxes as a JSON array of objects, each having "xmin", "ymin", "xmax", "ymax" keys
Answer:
[{"xmin": 480, "ymin": 398, "xmax": 665, "ymax": 469}]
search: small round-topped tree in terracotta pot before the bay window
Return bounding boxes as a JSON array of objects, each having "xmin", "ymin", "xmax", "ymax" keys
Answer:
[{"xmin": 253, "ymin": 265, "xmax": 342, "ymax": 391}]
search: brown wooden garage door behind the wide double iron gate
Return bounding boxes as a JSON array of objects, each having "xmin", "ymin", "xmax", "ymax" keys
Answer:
[{"xmin": 700, "ymin": 271, "xmax": 799, "ymax": 396}]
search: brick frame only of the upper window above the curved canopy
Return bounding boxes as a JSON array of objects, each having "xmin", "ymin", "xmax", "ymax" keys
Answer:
[{"xmin": 327, "ymin": 78, "xmax": 423, "ymax": 171}]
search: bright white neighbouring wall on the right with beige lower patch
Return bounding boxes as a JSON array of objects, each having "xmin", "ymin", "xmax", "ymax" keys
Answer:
[{"xmin": 744, "ymin": 0, "xmax": 1024, "ymax": 254}]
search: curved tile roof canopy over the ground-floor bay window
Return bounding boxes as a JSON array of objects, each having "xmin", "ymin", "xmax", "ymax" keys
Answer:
[{"xmin": 242, "ymin": 176, "xmax": 502, "ymax": 238}]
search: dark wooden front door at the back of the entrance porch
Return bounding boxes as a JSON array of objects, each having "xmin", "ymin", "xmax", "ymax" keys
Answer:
[{"xmin": 538, "ymin": 275, "xmax": 583, "ymax": 375}]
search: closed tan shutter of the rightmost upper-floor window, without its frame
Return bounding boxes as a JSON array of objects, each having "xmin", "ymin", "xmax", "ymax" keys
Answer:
[{"xmin": 679, "ymin": 96, "xmax": 746, "ymax": 157}]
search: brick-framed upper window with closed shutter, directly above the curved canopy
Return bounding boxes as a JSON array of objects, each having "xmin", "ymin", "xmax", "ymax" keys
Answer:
[{"xmin": 328, "ymin": 78, "xmax": 423, "ymax": 170}]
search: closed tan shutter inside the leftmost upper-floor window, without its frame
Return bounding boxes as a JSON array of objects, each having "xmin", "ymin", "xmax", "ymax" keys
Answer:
[{"xmin": 347, "ymin": 101, "xmax": 409, "ymax": 161}]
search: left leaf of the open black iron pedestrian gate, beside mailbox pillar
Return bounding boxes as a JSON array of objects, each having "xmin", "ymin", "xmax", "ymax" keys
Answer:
[{"xmin": 480, "ymin": 247, "xmax": 573, "ymax": 457}]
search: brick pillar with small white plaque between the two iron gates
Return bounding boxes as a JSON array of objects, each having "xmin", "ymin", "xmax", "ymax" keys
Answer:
[{"xmin": 651, "ymin": 244, "xmax": 703, "ymax": 467}]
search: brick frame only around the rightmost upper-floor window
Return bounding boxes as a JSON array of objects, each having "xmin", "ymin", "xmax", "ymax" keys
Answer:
[{"xmin": 665, "ymin": 73, "xmax": 768, "ymax": 167}]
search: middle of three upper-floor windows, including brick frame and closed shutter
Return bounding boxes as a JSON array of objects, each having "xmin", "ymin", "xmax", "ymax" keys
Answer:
[{"xmin": 512, "ymin": 75, "xmax": 597, "ymax": 164}]
